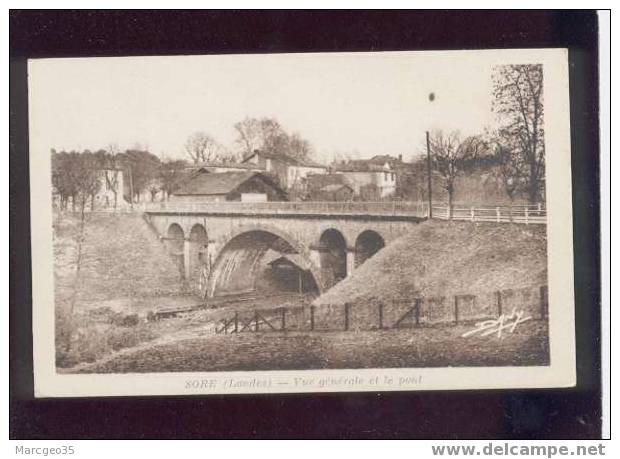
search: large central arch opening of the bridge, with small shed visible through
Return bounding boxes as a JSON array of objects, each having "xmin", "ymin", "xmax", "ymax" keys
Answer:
[{"xmin": 209, "ymin": 230, "xmax": 319, "ymax": 297}]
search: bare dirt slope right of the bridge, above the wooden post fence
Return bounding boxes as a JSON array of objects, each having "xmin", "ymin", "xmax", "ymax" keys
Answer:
[{"xmin": 315, "ymin": 221, "xmax": 547, "ymax": 304}]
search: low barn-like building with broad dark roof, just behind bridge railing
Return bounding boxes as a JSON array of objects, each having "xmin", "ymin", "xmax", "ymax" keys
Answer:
[{"xmin": 170, "ymin": 169, "xmax": 287, "ymax": 202}]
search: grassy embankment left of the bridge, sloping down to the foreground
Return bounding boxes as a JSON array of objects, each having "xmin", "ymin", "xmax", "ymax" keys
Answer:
[{"xmin": 54, "ymin": 214, "xmax": 189, "ymax": 367}]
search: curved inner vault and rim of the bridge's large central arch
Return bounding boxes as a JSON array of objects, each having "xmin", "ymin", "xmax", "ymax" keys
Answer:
[{"xmin": 208, "ymin": 225, "xmax": 324, "ymax": 297}]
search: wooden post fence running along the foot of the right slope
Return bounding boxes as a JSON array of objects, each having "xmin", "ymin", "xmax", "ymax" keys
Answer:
[{"xmin": 215, "ymin": 286, "xmax": 548, "ymax": 334}]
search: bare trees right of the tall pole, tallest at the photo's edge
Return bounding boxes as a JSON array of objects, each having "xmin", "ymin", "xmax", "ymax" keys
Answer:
[{"xmin": 429, "ymin": 64, "xmax": 545, "ymax": 214}]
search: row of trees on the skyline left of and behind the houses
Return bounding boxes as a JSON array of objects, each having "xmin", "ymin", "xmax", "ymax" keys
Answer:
[{"xmin": 52, "ymin": 117, "xmax": 314, "ymax": 211}]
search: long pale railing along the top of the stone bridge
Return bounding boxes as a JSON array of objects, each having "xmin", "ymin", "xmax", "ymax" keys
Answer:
[{"xmin": 144, "ymin": 201, "xmax": 428, "ymax": 218}]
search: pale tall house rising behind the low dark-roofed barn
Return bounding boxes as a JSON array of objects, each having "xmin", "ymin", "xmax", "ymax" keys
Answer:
[{"xmin": 241, "ymin": 150, "xmax": 327, "ymax": 190}]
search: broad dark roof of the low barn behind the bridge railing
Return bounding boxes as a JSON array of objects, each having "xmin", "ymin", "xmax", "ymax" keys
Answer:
[{"xmin": 173, "ymin": 171, "xmax": 284, "ymax": 195}]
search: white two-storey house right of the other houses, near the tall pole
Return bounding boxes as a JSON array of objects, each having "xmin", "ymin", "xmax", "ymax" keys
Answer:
[{"xmin": 334, "ymin": 159, "xmax": 396, "ymax": 199}]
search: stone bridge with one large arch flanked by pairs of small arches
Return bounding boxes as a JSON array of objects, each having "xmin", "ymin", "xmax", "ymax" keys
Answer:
[{"xmin": 145, "ymin": 202, "xmax": 427, "ymax": 297}]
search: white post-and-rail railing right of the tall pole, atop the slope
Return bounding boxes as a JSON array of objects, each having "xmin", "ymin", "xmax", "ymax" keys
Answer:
[{"xmin": 433, "ymin": 204, "xmax": 547, "ymax": 225}]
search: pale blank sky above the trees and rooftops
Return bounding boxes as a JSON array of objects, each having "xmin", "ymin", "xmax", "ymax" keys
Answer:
[{"xmin": 29, "ymin": 52, "xmax": 504, "ymax": 162}]
